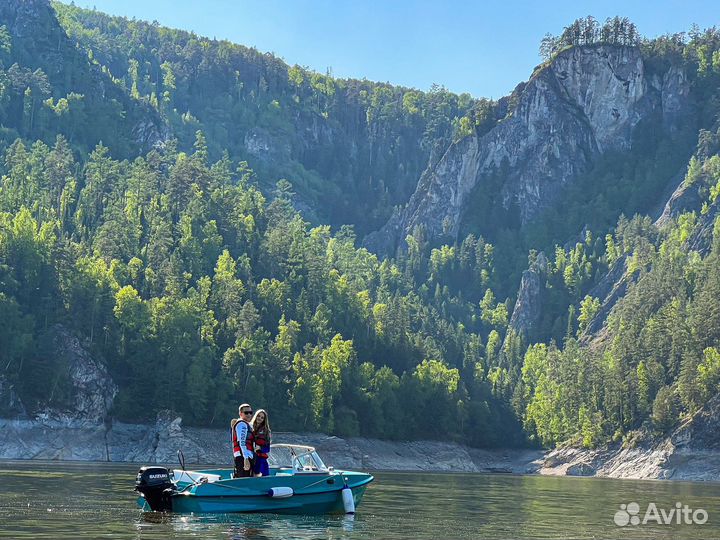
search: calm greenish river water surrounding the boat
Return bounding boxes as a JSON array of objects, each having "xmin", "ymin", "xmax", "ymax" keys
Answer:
[{"xmin": 0, "ymin": 461, "xmax": 720, "ymax": 540}]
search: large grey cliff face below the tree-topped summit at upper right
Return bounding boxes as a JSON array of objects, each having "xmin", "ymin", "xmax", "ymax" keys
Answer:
[{"xmin": 367, "ymin": 45, "xmax": 689, "ymax": 252}]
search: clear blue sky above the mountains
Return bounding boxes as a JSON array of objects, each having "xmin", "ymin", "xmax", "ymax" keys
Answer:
[{"xmin": 67, "ymin": 0, "xmax": 720, "ymax": 99}]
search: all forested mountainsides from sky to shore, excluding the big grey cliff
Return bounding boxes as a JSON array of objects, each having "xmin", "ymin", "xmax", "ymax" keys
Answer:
[{"xmin": 0, "ymin": 0, "xmax": 720, "ymax": 446}]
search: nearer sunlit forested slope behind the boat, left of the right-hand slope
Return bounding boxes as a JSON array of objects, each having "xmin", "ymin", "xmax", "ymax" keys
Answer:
[{"xmin": 0, "ymin": 130, "xmax": 519, "ymax": 444}]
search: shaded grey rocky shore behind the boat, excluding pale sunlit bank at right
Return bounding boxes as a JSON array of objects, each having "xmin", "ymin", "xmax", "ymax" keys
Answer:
[{"xmin": 0, "ymin": 413, "xmax": 542, "ymax": 474}]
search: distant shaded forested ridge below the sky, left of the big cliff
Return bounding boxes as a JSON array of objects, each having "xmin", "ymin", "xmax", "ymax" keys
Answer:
[{"xmin": 54, "ymin": 3, "xmax": 489, "ymax": 234}]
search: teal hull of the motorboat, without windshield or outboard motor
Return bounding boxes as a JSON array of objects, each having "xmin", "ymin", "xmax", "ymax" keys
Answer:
[{"xmin": 138, "ymin": 470, "xmax": 373, "ymax": 514}]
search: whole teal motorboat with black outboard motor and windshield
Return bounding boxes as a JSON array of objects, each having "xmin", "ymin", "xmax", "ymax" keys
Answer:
[{"xmin": 135, "ymin": 444, "xmax": 373, "ymax": 514}]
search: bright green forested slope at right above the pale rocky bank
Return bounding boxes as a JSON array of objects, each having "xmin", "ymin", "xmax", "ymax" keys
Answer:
[{"xmin": 519, "ymin": 143, "xmax": 720, "ymax": 446}]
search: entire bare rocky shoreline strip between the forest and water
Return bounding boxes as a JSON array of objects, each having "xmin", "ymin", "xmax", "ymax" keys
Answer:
[{"xmin": 0, "ymin": 400, "xmax": 720, "ymax": 481}]
